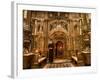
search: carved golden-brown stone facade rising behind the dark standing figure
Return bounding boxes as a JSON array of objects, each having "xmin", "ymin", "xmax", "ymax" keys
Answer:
[{"xmin": 23, "ymin": 10, "xmax": 91, "ymax": 69}]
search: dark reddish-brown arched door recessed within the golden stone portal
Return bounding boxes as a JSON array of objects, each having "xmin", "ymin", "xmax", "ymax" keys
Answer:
[{"xmin": 55, "ymin": 41, "xmax": 64, "ymax": 58}]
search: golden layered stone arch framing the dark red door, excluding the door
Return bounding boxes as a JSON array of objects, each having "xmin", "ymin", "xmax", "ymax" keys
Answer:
[{"xmin": 48, "ymin": 27, "xmax": 68, "ymax": 58}]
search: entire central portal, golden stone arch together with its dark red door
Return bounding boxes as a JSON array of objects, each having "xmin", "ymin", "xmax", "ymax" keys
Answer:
[{"xmin": 48, "ymin": 24, "xmax": 68, "ymax": 59}]
